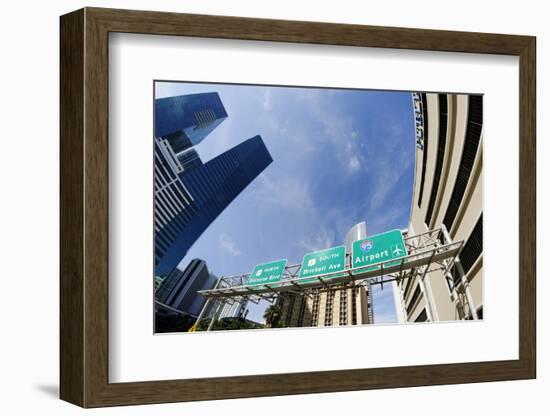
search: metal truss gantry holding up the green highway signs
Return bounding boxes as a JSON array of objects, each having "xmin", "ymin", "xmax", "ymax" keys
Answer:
[{"xmin": 198, "ymin": 228, "xmax": 464, "ymax": 308}]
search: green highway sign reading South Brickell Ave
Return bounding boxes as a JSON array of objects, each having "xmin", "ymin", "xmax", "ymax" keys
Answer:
[{"xmin": 300, "ymin": 246, "xmax": 346, "ymax": 283}]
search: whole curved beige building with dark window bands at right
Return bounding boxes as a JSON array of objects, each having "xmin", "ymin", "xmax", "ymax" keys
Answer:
[{"xmin": 394, "ymin": 93, "xmax": 483, "ymax": 322}]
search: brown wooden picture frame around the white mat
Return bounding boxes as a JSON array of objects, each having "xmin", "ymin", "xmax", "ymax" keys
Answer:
[{"xmin": 60, "ymin": 8, "xmax": 536, "ymax": 407}]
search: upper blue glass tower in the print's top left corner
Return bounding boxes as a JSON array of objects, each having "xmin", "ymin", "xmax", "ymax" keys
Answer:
[{"xmin": 155, "ymin": 92, "xmax": 227, "ymax": 154}]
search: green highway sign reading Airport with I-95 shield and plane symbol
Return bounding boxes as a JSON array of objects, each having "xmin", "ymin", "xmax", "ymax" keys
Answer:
[{"xmin": 352, "ymin": 230, "xmax": 407, "ymax": 273}]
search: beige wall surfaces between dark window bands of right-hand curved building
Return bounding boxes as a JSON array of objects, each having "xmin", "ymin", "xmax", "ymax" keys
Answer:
[{"xmin": 395, "ymin": 94, "xmax": 483, "ymax": 322}]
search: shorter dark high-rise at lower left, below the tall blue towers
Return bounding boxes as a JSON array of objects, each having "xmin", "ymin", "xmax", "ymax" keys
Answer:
[{"xmin": 156, "ymin": 259, "xmax": 218, "ymax": 317}]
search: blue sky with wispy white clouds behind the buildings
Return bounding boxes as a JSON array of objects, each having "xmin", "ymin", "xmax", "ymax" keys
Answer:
[{"xmin": 155, "ymin": 82, "xmax": 415, "ymax": 323}]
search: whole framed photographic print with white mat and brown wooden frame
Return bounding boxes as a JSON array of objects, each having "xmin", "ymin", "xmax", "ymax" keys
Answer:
[{"xmin": 60, "ymin": 8, "xmax": 536, "ymax": 407}]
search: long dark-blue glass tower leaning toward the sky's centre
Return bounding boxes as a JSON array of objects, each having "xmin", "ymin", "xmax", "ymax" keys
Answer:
[{"xmin": 155, "ymin": 136, "xmax": 273, "ymax": 275}]
